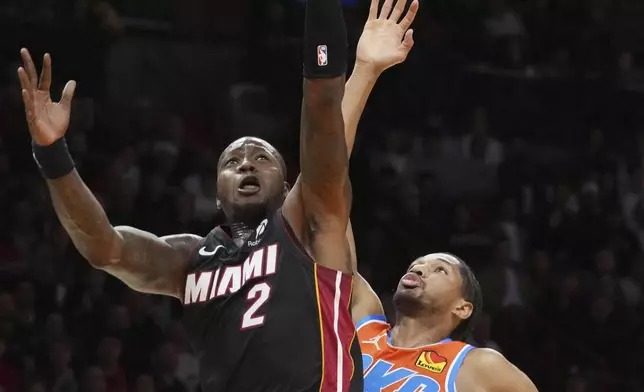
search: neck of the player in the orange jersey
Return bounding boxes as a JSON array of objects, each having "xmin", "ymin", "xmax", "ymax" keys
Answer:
[{"xmin": 391, "ymin": 314, "xmax": 451, "ymax": 348}]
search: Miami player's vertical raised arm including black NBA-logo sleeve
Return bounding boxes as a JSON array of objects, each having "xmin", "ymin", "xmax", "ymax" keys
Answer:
[{"xmin": 283, "ymin": 0, "xmax": 352, "ymax": 273}]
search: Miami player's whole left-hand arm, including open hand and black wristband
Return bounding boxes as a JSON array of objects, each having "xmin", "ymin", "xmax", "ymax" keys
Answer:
[{"xmin": 18, "ymin": 49, "xmax": 200, "ymax": 298}]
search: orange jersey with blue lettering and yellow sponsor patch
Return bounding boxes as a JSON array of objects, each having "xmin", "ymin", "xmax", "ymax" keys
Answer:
[{"xmin": 356, "ymin": 315, "xmax": 474, "ymax": 392}]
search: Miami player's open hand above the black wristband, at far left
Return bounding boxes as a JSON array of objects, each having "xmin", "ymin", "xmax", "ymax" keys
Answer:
[{"xmin": 18, "ymin": 49, "xmax": 76, "ymax": 146}]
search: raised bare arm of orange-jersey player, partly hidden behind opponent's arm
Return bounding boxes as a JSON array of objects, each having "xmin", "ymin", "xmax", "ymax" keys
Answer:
[{"xmin": 342, "ymin": 0, "xmax": 418, "ymax": 323}]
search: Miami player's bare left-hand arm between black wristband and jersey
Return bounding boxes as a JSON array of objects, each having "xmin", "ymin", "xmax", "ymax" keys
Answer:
[{"xmin": 47, "ymin": 170, "xmax": 200, "ymax": 297}]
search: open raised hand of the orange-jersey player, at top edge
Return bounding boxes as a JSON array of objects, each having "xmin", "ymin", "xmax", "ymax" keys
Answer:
[{"xmin": 356, "ymin": 0, "xmax": 418, "ymax": 73}]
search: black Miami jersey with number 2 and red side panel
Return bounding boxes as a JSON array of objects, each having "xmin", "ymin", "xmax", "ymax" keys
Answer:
[{"xmin": 183, "ymin": 210, "xmax": 363, "ymax": 392}]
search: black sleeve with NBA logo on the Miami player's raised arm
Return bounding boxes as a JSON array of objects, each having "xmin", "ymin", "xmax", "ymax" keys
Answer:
[{"xmin": 303, "ymin": 0, "xmax": 348, "ymax": 79}]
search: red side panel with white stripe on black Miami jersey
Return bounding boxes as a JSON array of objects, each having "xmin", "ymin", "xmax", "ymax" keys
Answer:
[{"xmin": 314, "ymin": 264, "xmax": 355, "ymax": 392}]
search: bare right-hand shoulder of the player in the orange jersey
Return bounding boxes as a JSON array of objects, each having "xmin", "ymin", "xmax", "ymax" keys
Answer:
[{"xmin": 459, "ymin": 348, "xmax": 537, "ymax": 392}]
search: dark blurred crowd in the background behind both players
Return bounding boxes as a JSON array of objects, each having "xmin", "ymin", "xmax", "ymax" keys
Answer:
[{"xmin": 0, "ymin": 0, "xmax": 644, "ymax": 392}]
